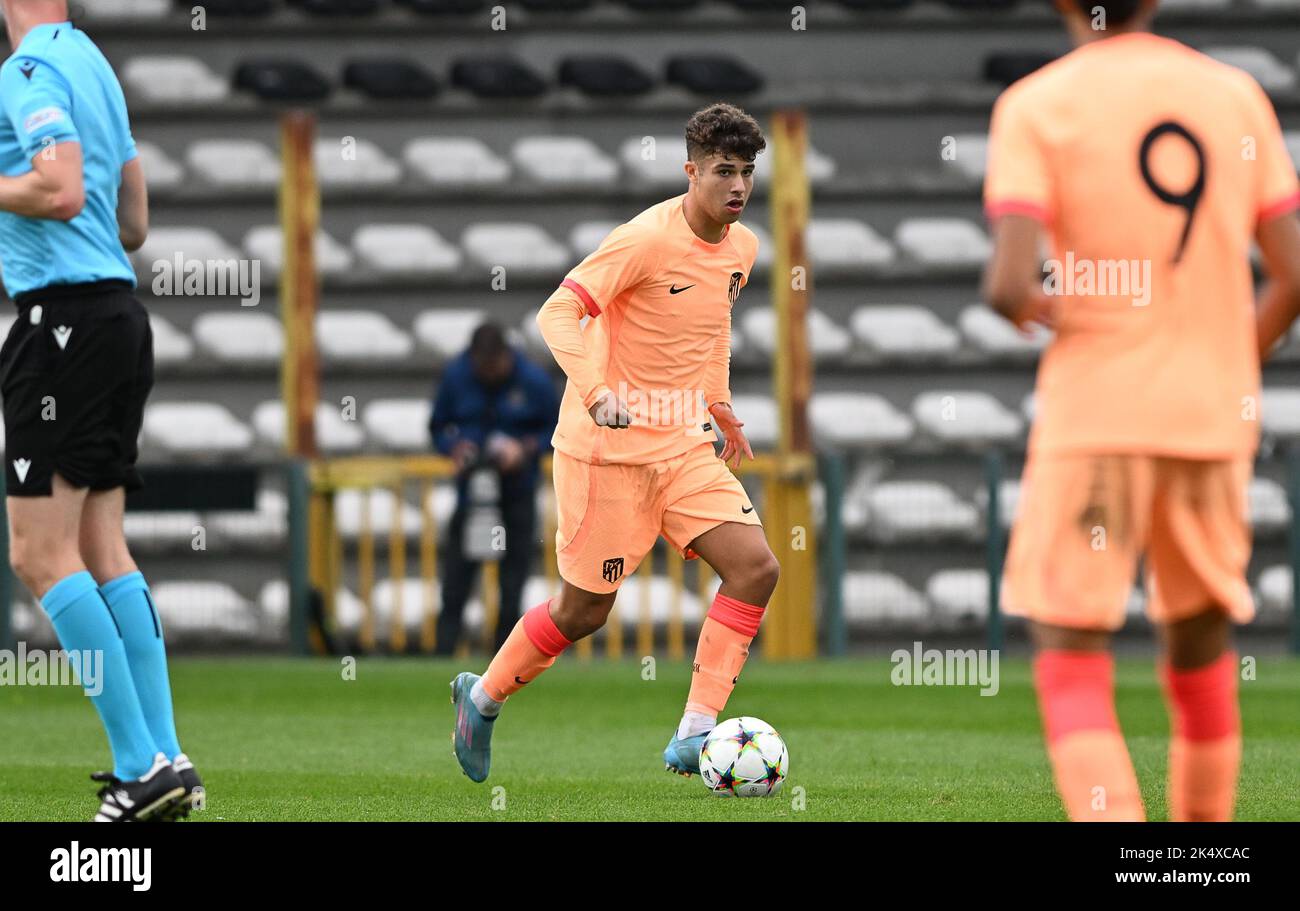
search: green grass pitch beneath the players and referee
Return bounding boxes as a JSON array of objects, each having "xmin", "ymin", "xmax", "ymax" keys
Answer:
[{"xmin": 0, "ymin": 649, "xmax": 1300, "ymax": 821}]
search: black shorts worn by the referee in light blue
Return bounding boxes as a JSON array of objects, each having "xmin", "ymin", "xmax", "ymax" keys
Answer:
[{"xmin": 0, "ymin": 281, "xmax": 153, "ymax": 496}]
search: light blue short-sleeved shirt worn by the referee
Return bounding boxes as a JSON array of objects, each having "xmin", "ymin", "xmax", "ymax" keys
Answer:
[{"xmin": 0, "ymin": 22, "xmax": 135, "ymax": 298}]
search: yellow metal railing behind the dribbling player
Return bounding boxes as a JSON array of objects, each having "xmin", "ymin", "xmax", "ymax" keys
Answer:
[{"xmin": 308, "ymin": 454, "xmax": 816, "ymax": 659}]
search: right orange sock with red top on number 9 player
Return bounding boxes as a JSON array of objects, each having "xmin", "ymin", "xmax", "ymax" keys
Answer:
[{"xmin": 1161, "ymin": 651, "xmax": 1242, "ymax": 823}]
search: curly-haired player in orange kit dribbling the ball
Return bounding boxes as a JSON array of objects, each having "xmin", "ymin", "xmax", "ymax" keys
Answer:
[{"xmin": 452, "ymin": 104, "xmax": 780, "ymax": 781}]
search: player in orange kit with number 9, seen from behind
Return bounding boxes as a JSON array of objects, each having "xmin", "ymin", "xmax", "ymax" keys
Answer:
[{"xmin": 984, "ymin": 0, "xmax": 1300, "ymax": 821}]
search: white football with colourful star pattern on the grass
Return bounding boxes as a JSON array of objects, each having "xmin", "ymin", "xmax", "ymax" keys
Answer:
[{"xmin": 699, "ymin": 715, "xmax": 790, "ymax": 797}]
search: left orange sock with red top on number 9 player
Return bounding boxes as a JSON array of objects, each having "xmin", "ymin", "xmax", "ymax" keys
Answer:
[{"xmin": 1034, "ymin": 648, "xmax": 1145, "ymax": 823}]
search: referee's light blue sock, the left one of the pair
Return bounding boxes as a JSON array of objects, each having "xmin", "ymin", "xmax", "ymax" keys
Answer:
[{"xmin": 40, "ymin": 569, "xmax": 157, "ymax": 780}]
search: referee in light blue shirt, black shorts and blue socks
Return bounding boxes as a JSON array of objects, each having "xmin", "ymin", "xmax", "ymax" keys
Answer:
[{"xmin": 0, "ymin": 0, "xmax": 203, "ymax": 821}]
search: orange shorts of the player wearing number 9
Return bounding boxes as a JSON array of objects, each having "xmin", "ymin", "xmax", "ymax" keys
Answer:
[{"xmin": 1002, "ymin": 454, "xmax": 1255, "ymax": 630}]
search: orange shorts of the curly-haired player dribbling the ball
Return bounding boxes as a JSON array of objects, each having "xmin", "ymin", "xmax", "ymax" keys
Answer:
[{"xmin": 553, "ymin": 443, "xmax": 762, "ymax": 593}]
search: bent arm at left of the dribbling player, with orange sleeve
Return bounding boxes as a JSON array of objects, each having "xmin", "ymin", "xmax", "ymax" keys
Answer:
[{"xmin": 537, "ymin": 222, "xmax": 658, "ymax": 428}]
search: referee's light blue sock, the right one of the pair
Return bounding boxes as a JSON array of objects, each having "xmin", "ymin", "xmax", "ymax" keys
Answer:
[{"xmin": 99, "ymin": 571, "xmax": 181, "ymax": 759}]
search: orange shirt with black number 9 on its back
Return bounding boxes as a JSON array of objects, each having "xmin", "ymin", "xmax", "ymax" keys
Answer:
[{"xmin": 985, "ymin": 34, "xmax": 1295, "ymax": 457}]
